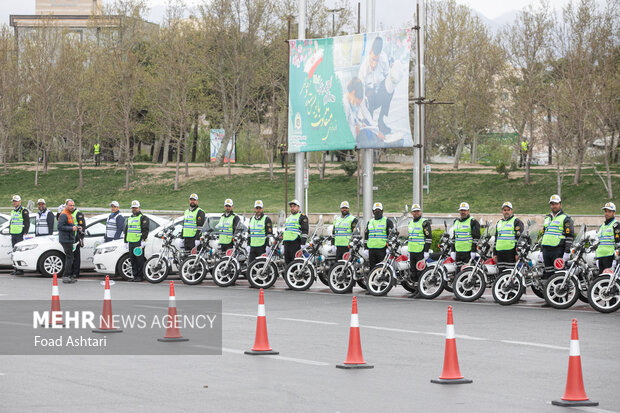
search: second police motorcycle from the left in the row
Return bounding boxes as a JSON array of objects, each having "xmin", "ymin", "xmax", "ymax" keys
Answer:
[{"xmin": 179, "ymin": 227, "xmax": 221, "ymax": 285}]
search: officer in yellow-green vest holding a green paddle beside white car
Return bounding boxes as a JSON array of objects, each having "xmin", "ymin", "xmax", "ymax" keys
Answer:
[{"xmin": 125, "ymin": 201, "xmax": 149, "ymax": 282}]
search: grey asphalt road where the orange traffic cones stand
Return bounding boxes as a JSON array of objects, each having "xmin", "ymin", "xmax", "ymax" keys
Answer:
[{"xmin": 0, "ymin": 272, "xmax": 620, "ymax": 412}]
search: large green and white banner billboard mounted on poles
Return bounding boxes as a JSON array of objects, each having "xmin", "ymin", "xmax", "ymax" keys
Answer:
[{"xmin": 288, "ymin": 29, "xmax": 413, "ymax": 152}]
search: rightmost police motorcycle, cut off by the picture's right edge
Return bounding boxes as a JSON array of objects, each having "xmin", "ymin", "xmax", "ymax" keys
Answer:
[{"xmin": 588, "ymin": 245, "xmax": 620, "ymax": 313}]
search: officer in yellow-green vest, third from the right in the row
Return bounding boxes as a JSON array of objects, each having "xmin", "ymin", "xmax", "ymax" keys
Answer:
[{"xmin": 493, "ymin": 202, "xmax": 523, "ymax": 272}]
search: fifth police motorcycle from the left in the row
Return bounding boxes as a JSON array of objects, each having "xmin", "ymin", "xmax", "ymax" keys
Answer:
[{"xmin": 284, "ymin": 215, "xmax": 333, "ymax": 291}]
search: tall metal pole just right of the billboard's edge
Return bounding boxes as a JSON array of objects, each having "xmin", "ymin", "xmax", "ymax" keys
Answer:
[{"xmin": 412, "ymin": 0, "xmax": 425, "ymax": 207}]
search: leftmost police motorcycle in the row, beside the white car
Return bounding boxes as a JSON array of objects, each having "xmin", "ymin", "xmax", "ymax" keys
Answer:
[{"xmin": 144, "ymin": 222, "xmax": 185, "ymax": 284}]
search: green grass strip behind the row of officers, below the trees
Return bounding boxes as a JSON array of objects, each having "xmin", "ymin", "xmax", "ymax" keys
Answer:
[{"xmin": 0, "ymin": 164, "xmax": 620, "ymax": 215}]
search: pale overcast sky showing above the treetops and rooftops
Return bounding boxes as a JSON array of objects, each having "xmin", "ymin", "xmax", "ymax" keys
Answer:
[{"xmin": 0, "ymin": 0, "xmax": 570, "ymax": 29}]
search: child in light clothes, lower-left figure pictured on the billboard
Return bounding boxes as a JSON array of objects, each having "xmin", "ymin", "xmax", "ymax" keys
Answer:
[{"xmin": 344, "ymin": 77, "xmax": 385, "ymax": 148}]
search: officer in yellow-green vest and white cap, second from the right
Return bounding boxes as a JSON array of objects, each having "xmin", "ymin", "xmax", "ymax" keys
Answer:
[{"xmin": 540, "ymin": 195, "xmax": 575, "ymax": 279}]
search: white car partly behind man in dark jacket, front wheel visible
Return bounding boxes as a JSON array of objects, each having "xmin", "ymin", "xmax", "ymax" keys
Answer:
[{"xmin": 13, "ymin": 213, "xmax": 166, "ymax": 277}]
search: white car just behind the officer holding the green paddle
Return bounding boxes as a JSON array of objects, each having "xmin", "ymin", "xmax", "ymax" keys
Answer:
[{"xmin": 93, "ymin": 213, "xmax": 243, "ymax": 280}]
